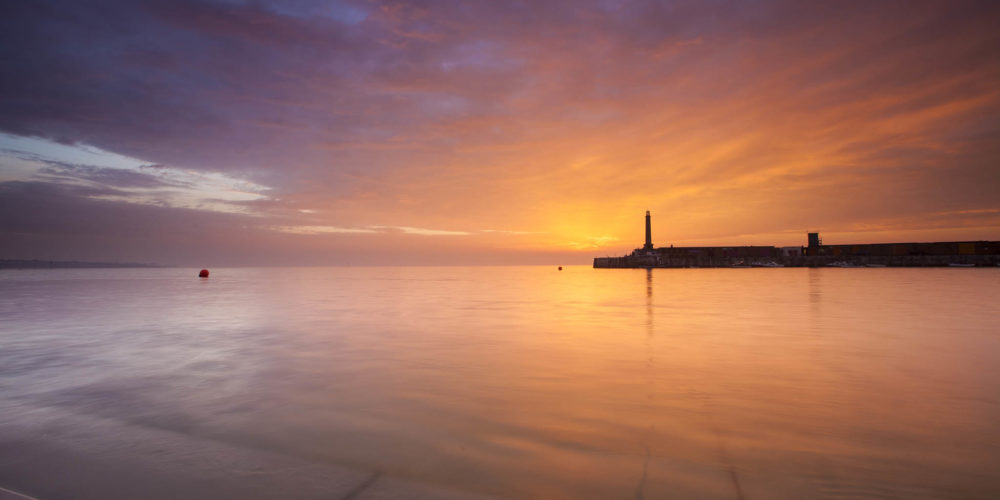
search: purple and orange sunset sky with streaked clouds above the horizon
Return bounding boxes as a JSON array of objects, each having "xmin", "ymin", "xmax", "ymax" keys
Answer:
[{"xmin": 0, "ymin": 0, "xmax": 1000, "ymax": 266}]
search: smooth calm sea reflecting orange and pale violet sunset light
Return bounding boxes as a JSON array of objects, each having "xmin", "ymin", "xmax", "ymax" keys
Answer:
[{"xmin": 0, "ymin": 267, "xmax": 1000, "ymax": 499}]
